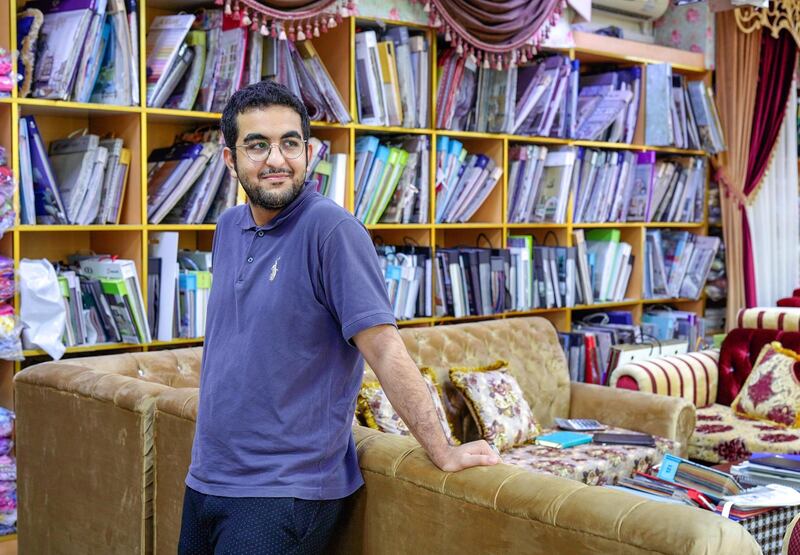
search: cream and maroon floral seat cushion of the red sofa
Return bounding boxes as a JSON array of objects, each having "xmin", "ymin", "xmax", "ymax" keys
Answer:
[{"xmin": 689, "ymin": 405, "xmax": 800, "ymax": 464}]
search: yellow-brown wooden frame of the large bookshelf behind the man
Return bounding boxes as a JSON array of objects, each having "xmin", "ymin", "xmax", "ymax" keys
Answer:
[{"xmin": 0, "ymin": 0, "xmax": 710, "ymax": 376}]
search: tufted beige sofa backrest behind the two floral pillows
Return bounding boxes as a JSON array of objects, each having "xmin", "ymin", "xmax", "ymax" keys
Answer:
[{"xmin": 388, "ymin": 317, "xmax": 570, "ymax": 439}]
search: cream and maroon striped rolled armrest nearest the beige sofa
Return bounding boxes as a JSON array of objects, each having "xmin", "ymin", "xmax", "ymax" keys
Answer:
[{"xmin": 611, "ymin": 350, "xmax": 719, "ymax": 407}]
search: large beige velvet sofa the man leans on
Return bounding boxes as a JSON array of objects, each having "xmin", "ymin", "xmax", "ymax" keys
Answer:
[{"xmin": 16, "ymin": 318, "xmax": 759, "ymax": 555}]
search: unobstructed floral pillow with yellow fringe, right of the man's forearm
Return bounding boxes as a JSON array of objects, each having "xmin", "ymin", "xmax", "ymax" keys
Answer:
[{"xmin": 450, "ymin": 360, "xmax": 539, "ymax": 451}]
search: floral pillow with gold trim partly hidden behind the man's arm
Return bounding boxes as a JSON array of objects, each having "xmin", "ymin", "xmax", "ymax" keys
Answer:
[{"xmin": 358, "ymin": 368, "xmax": 459, "ymax": 445}]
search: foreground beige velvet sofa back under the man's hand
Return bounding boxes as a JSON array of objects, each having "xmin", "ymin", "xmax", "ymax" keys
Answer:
[{"xmin": 332, "ymin": 428, "xmax": 760, "ymax": 555}]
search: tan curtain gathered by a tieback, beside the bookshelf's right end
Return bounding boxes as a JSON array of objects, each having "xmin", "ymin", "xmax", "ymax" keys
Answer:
[{"xmin": 716, "ymin": 11, "xmax": 761, "ymax": 328}]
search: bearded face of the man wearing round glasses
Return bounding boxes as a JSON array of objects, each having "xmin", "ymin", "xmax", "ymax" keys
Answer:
[{"xmin": 225, "ymin": 106, "xmax": 308, "ymax": 210}]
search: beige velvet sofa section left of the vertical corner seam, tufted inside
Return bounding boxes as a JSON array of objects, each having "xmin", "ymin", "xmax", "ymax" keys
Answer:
[{"xmin": 14, "ymin": 347, "xmax": 202, "ymax": 554}]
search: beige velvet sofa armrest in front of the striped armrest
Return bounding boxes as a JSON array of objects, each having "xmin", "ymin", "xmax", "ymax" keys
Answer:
[{"xmin": 569, "ymin": 382, "xmax": 695, "ymax": 455}]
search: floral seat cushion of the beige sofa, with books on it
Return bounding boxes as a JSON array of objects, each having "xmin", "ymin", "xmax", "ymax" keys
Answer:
[{"xmin": 502, "ymin": 428, "xmax": 680, "ymax": 485}]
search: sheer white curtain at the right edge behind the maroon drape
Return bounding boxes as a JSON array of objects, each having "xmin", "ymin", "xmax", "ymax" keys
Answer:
[{"xmin": 747, "ymin": 85, "xmax": 800, "ymax": 306}]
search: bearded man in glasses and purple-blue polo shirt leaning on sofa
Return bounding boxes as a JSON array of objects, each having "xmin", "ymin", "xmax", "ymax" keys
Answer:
[{"xmin": 180, "ymin": 82, "xmax": 498, "ymax": 555}]
